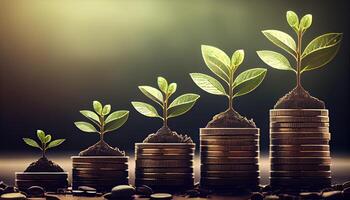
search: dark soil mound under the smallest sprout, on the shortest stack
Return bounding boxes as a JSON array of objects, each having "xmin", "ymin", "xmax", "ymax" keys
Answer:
[{"xmin": 25, "ymin": 157, "xmax": 63, "ymax": 172}]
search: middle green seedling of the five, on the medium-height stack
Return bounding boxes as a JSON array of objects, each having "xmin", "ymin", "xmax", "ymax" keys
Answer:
[{"xmin": 131, "ymin": 77, "xmax": 199, "ymax": 127}]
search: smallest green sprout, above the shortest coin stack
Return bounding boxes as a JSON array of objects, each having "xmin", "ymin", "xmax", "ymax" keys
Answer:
[{"xmin": 23, "ymin": 130, "xmax": 65, "ymax": 158}]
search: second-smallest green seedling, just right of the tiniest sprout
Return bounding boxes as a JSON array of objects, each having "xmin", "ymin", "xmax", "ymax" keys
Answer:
[{"xmin": 74, "ymin": 101, "xmax": 129, "ymax": 141}]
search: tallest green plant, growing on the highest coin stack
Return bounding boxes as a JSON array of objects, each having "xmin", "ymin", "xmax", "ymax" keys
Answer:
[{"xmin": 257, "ymin": 11, "xmax": 343, "ymax": 88}]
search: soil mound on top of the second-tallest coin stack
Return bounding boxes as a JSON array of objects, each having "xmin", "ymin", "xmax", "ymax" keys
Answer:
[{"xmin": 206, "ymin": 109, "xmax": 256, "ymax": 128}]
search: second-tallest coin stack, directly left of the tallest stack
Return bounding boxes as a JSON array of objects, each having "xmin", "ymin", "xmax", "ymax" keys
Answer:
[{"xmin": 200, "ymin": 128, "xmax": 260, "ymax": 190}]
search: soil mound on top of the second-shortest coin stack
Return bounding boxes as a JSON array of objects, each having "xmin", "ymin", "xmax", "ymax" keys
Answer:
[{"xmin": 79, "ymin": 140, "xmax": 125, "ymax": 156}]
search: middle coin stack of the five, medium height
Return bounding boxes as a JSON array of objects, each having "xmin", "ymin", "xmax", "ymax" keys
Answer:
[{"xmin": 135, "ymin": 143, "xmax": 195, "ymax": 191}]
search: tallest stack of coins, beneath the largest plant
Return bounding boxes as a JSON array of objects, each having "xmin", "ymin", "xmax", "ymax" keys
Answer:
[{"xmin": 270, "ymin": 109, "xmax": 331, "ymax": 190}]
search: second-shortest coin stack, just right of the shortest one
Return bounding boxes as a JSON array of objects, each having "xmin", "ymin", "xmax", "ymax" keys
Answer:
[{"xmin": 72, "ymin": 156, "xmax": 129, "ymax": 192}]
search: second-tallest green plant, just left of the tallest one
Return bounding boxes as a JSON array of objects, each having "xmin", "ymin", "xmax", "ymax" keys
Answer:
[{"xmin": 190, "ymin": 45, "xmax": 267, "ymax": 109}]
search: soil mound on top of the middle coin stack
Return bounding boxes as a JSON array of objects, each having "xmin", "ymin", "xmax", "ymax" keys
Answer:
[{"xmin": 143, "ymin": 126, "xmax": 193, "ymax": 143}]
